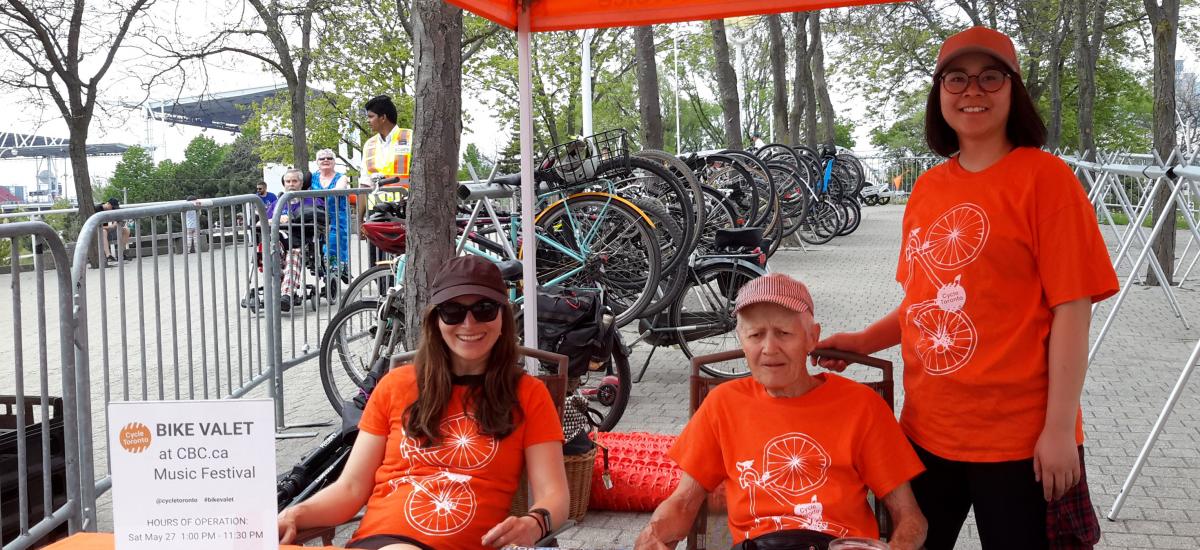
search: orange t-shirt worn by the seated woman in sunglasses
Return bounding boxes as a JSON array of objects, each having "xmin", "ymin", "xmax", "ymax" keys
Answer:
[{"xmin": 354, "ymin": 365, "xmax": 563, "ymax": 550}]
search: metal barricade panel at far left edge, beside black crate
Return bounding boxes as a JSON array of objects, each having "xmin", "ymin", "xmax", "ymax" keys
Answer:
[{"xmin": 0, "ymin": 222, "xmax": 86, "ymax": 550}]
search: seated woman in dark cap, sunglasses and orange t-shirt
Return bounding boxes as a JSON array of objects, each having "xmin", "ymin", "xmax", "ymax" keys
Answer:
[{"xmin": 280, "ymin": 256, "xmax": 568, "ymax": 550}]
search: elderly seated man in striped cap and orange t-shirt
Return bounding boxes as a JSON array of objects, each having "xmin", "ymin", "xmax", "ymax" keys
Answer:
[{"xmin": 637, "ymin": 273, "xmax": 926, "ymax": 550}]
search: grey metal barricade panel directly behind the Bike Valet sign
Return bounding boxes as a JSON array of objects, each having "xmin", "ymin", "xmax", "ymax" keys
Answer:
[{"xmin": 71, "ymin": 195, "xmax": 275, "ymax": 525}]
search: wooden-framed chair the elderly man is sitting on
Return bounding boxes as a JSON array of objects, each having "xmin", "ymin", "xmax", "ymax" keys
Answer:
[{"xmin": 688, "ymin": 349, "xmax": 895, "ymax": 550}]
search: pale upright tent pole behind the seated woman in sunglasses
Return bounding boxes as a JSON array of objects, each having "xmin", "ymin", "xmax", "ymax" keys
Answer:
[{"xmin": 517, "ymin": 1, "xmax": 538, "ymax": 375}]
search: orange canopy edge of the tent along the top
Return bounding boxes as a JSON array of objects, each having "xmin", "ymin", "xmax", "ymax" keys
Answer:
[{"xmin": 446, "ymin": 0, "xmax": 897, "ymax": 32}]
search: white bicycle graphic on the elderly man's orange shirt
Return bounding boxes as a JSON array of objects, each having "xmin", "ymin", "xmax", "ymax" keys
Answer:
[{"xmin": 737, "ymin": 432, "xmax": 848, "ymax": 537}]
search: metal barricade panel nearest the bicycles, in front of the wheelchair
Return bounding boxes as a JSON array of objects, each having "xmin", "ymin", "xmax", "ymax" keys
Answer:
[{"xmin": 263, "ymin": 189, "xmax": 372, "ymax": 436}]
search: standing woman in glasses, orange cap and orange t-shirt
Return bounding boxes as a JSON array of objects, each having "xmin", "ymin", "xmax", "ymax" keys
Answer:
[{"xmin": 818, "ymin": 26, "xmax": 1117, "ymax": 550}]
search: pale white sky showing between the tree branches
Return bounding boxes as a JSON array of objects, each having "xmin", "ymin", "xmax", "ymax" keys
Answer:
[{"xmin": 0, "ymin": 2, "xmax": 1198, "ymax": 201}]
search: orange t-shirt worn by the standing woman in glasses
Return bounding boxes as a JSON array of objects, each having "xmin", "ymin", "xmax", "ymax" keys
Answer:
[{"xmin": 896, "ymin": 148, "xmax": 1118, "ymax": 462}]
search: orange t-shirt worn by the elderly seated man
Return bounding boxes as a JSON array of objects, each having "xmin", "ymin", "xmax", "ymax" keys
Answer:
[{"xmin": 667, "ymin": 373, "xmax": 924, "ymax": 543}]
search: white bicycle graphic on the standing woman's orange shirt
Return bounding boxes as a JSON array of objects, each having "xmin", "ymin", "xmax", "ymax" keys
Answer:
[{"xmin": 904, "ymin": 203, "xmax": 989, "ymax": 375}]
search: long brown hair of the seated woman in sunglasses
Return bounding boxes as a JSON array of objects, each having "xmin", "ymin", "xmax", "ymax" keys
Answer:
[{"xmin": 404, "ymin": 304, "xmax": 524, "ymax": 447}]
